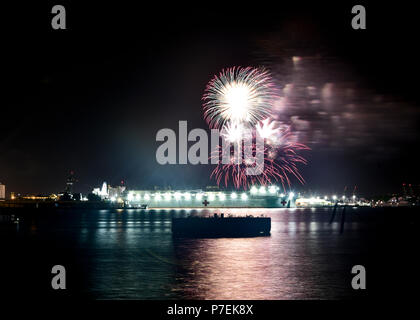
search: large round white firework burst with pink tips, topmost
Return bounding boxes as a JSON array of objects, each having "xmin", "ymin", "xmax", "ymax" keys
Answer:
[{"xmin": 203, "ymin": 67, "xmax": 278, "ymax": 128}]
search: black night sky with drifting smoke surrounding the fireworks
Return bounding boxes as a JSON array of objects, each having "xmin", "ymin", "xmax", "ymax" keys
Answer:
[{"xmin": 0, "ymin": 2, "xmax": 420, "ymax": 194}]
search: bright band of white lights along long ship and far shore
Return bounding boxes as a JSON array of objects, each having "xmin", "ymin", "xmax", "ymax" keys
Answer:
[{"xmin": 85, "ymin": 182, "xmax": 371, "ymax": 208}]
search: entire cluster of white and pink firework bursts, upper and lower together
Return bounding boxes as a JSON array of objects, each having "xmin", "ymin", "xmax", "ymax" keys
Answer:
[{"xmin": 203, "ymin": 67, "xmax": 309, "ymax": 189}]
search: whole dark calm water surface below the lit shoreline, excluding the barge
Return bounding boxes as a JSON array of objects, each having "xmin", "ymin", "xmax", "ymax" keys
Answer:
[{"xmin": 3, "ymin": 208, "xmax": 414, "ymax": 299}]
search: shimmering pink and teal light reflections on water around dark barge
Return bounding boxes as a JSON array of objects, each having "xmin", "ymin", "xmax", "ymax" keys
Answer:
[{"xmin": 74, "ymin": 208, "xmax": 358, "ymax": 299}]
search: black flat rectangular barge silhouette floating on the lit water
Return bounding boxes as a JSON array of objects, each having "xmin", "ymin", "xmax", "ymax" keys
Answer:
[{"xmin": 172, "ymin": 213, "xmax": 271, "ymax": 238}]
